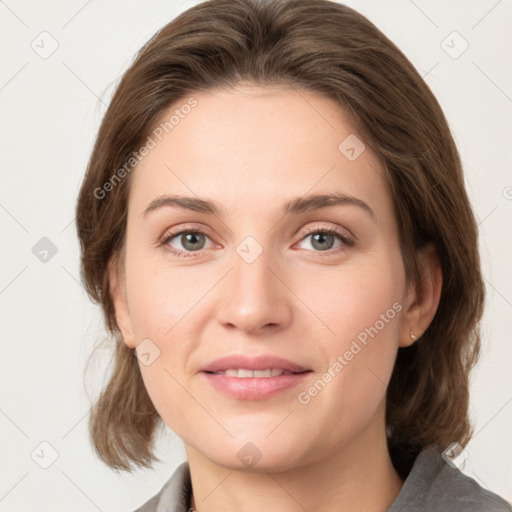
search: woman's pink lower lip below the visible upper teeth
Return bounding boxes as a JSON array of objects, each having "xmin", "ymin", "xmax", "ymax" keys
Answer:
[{"xmin": 201, "ymin": 372, "xmax": 311, "ymax": 400}]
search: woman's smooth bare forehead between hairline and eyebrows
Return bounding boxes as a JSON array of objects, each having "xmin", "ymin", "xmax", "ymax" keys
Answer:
[{"xmin": 130, "ymin": 85, "xmax": 390, "ymax": 223}]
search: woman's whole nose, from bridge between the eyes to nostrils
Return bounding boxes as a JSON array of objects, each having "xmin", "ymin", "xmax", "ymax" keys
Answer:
[{"xmin": 214, "ymin": 236, "xmax": 291, "ymax": 332}]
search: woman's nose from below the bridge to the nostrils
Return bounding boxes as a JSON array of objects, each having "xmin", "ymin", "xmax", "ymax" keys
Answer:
[{"xmin": 217, "ymin": 244, "xmax": 294, "ymax": 335}]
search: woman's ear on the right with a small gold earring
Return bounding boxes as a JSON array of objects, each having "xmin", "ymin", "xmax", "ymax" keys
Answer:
[{"xmin": 399, "ymin": 244, "xmax": 443, "ymax": 347}]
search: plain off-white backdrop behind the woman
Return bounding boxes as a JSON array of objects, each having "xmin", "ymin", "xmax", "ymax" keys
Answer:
[{"xmin": 0, "ymin": 0, "xmax": 512, "ymax": 512}]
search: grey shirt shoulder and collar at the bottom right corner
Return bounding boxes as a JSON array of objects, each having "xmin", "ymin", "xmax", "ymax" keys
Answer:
[{"xmin": 388, "ymin": 446, "xmax": 512, "ymax": 512}]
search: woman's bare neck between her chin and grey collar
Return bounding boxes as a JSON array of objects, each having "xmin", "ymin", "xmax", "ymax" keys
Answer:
[{"xmin": 185, "ymin": 404, "xmax": 403, "ymax": 512}]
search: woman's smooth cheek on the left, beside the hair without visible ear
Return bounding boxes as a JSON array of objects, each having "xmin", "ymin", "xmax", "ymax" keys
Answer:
[{"xmin": 126, "ymin": 251, "xmax": 206, "ymax": 426}]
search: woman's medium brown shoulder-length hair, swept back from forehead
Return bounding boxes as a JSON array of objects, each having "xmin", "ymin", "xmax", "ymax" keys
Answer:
[{"xmin": 76, "ymin": 0, "xmax": 484, "ymax": 474}]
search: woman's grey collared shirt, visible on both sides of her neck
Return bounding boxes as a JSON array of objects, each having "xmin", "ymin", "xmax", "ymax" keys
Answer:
[{"xmin": 135, "ymin": 446, "xmax": 512, "ymax": 512}]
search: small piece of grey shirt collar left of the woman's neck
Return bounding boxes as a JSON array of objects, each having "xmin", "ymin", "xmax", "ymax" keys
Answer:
[{"xmin": 133, "ymin": 462, "xmax": 191, "ymax": 512}]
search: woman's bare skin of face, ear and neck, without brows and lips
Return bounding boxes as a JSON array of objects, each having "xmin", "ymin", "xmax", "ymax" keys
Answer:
[{"xmin": 110, "ymin": 85, "xmax": 442, "ymax": 512}]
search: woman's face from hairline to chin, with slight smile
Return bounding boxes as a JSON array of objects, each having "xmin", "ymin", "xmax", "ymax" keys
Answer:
[{"xmin": 111, "ymin": 85, "xmax": 416, "ymax": 471}]
